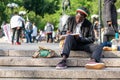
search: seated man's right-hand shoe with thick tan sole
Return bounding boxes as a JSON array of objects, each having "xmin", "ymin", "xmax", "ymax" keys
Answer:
[{"xmin": 85, "ymin": 61, "xmax": 105, "ymax": 69}]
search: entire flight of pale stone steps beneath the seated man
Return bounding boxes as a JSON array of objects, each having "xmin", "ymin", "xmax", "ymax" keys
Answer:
[{"xmin": 0, "ymin": 43, "xmax": 120, "ymax": 80}]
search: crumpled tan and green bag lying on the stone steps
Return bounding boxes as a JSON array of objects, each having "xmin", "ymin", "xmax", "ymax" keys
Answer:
[{"xmin": 32, "ymin": 47, "xmax": 55, "ymax": 58}]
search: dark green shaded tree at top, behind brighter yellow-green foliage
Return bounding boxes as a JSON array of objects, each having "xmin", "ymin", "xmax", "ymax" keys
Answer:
[{"xmin": 23, "ymin": 0, "xmax": 59, "ymax": 17}]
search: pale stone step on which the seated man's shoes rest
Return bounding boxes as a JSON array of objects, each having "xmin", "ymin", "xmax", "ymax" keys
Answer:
[{"xmin": 0, "ymin": 67, "xmax": 120, "ymax": 79}]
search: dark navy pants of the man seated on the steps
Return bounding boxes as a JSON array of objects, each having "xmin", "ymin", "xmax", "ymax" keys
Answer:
[{"xmin": 61, "ymin": 35, "xmax": 103, "ymax": 62}]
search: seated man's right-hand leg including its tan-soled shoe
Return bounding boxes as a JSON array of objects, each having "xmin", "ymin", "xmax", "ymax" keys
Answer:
[{"xmin": 84, "ymin": 44, "xmax": 105, "ymax": 69}]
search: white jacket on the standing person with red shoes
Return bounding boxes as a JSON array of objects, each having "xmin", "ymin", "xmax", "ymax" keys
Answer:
[{"xmin": 10, "ymin": 15, "xmax": 25, "ymax": 28}]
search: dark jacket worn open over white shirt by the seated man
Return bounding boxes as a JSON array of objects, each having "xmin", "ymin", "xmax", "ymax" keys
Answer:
[{"xmin": 67, "ymin": 17, "xmax": 95, "ymax": 44}]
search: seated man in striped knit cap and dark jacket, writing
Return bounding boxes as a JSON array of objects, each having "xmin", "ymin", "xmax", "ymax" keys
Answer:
[{"xmin": 56, "ymin": 7, "xmax": 105, "ymax": 69}]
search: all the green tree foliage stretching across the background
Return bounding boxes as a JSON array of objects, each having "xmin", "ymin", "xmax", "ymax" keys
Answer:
[{"xmin": 0, "ymin": 0, "xmax": 120, "ymax": 30}]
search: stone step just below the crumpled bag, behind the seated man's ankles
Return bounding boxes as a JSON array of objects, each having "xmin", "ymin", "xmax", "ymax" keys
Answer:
[{"xmin": 0, "ymin": 57, "xmax": 120, "ymax": 67}]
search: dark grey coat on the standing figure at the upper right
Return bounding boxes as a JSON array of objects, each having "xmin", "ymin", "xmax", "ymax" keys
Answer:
[{"xmin": 103, "ymin": 0, "xmax": 118, "ymax": 31}]
